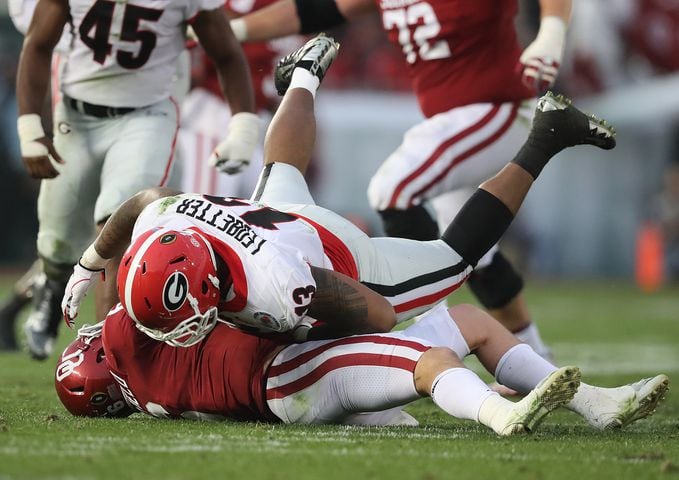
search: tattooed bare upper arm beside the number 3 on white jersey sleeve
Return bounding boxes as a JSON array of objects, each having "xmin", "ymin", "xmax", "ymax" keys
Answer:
[{"xmin": 307, "ymin": 267, "xmax": 396, "ymax": 340}]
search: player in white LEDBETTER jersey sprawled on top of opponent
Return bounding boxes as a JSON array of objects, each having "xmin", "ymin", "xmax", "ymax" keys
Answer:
[{"xmin": 62, "ymin": 35, "xmax": 615, "ymax": 347}]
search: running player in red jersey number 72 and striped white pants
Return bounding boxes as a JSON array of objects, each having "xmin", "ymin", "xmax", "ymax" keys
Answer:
[{"xmin": 232, "ymin": 0, "xmax": 571, "ymax": 356}]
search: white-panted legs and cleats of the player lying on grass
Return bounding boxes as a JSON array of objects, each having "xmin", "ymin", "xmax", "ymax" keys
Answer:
[{"xmin": 266, "ymin": 305, "xmax": 669, "ymax": 435}]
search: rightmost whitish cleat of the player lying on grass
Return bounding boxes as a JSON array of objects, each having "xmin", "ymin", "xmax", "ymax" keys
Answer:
[{"xmin": 583, "ymin": 375, "xmax": 669, "ymax": 430}]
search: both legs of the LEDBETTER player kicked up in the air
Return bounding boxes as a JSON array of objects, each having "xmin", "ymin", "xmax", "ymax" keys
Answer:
[{"xmin": 253, "ymin": 36, "xmax": 615, "ymax": 334}]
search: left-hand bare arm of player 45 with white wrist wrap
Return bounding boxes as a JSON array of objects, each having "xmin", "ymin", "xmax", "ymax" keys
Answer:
[{"xmin": 17, "ymin": 0, "xmax": 69, "ymax": 178}]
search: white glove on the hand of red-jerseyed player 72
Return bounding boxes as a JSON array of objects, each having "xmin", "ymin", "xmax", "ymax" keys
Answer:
[{"xmin": 519, "ymin": 16, "xmax": 566, "ymax": 94}]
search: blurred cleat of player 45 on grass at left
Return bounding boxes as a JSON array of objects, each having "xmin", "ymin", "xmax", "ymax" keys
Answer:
[{"xmin": 24, "ymin": 280, "xmax": 66, "ymax": 360}]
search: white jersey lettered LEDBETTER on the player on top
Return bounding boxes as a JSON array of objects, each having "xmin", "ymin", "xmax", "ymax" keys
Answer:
[{"xmin": 132, "ymin": 194, "xmax": 332, "ymax": 332}]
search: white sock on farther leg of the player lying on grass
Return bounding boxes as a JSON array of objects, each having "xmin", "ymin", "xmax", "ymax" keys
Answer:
[{"xmin": 495, "ymin": 343, "xmax": 557, "ymax": 393}]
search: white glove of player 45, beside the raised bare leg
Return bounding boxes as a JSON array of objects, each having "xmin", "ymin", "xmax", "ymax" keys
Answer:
[{"xmin": 210, "ymin": 112, "xmax": 261, "ymax": 175}]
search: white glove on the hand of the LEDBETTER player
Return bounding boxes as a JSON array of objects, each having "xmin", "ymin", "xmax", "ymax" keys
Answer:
[{"xmin": 61, "ymin": 244, "xmax": 107, "ymax": 328}]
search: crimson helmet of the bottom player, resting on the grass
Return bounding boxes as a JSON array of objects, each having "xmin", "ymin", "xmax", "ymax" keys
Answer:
[{"xmin": 54, "ymin": 337, "xmax": 134, "ymax": 417}]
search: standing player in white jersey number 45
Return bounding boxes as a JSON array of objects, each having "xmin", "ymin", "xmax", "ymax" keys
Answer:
[{"xmin": 17, "ymin": 0, "xmax": 260, "ymax": 358}]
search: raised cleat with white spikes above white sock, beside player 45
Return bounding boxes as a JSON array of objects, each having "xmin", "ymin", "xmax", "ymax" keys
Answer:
[{"xmin": 274, "ymin": 33, "xmax": 339, "ymax": 96}]
